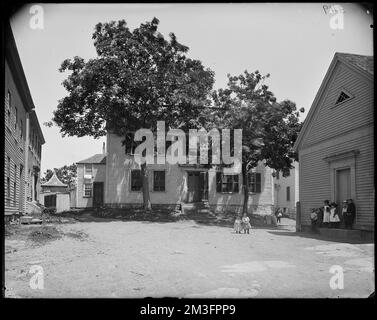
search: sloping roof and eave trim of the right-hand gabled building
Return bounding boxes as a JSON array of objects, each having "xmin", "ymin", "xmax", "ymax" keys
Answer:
[{"xmin": 293, "ymin": 52, "xmax": 374, "ymax": 152}]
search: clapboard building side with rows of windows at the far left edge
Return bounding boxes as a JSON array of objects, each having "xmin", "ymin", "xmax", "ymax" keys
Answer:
[{"xmin": 3, "ymin": 23, "xmax": 45, "ymax": 216}]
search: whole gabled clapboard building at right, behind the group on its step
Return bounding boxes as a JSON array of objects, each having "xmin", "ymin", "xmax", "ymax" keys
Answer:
[{"xmin": 295, "ymin": 53, "xmax": 374, "ymax": 232}]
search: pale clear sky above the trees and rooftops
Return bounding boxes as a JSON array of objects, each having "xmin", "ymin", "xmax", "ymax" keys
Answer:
[{"xmin": 11, "ymin": 3, "xmax": 373, "ymax": 172}]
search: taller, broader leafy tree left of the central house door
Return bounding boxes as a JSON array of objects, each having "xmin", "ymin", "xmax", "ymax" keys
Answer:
[{"xmin": 53, "ymin": 18, "xmax": 214, "ymax": 210}]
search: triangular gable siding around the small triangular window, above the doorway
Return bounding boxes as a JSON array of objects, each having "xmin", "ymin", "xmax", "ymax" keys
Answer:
[{"xmin": 302, "ymin": 62, "xmax": 373, "ymax": 149}]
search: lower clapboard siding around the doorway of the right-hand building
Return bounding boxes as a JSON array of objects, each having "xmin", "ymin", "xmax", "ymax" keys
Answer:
[{"xmin": 300, "ymin": 130, "xmax": 374, "ymax": 229}]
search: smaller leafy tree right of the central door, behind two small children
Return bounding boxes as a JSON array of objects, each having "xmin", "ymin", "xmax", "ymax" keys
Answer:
[{"xmin": 207, "ymin": 71, "xmax": 304, "ymax": 212}]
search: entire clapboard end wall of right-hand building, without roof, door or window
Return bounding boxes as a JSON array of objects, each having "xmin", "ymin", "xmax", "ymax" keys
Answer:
[{"xmin": 299, "ymin": 60, "xmax": 374, "ymax": 230}]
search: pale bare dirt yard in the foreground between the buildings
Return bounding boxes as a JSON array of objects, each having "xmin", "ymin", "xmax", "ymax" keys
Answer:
[{"xmin": 5, "ymin": 219, "xmax": 374, "ymax": 298}]
